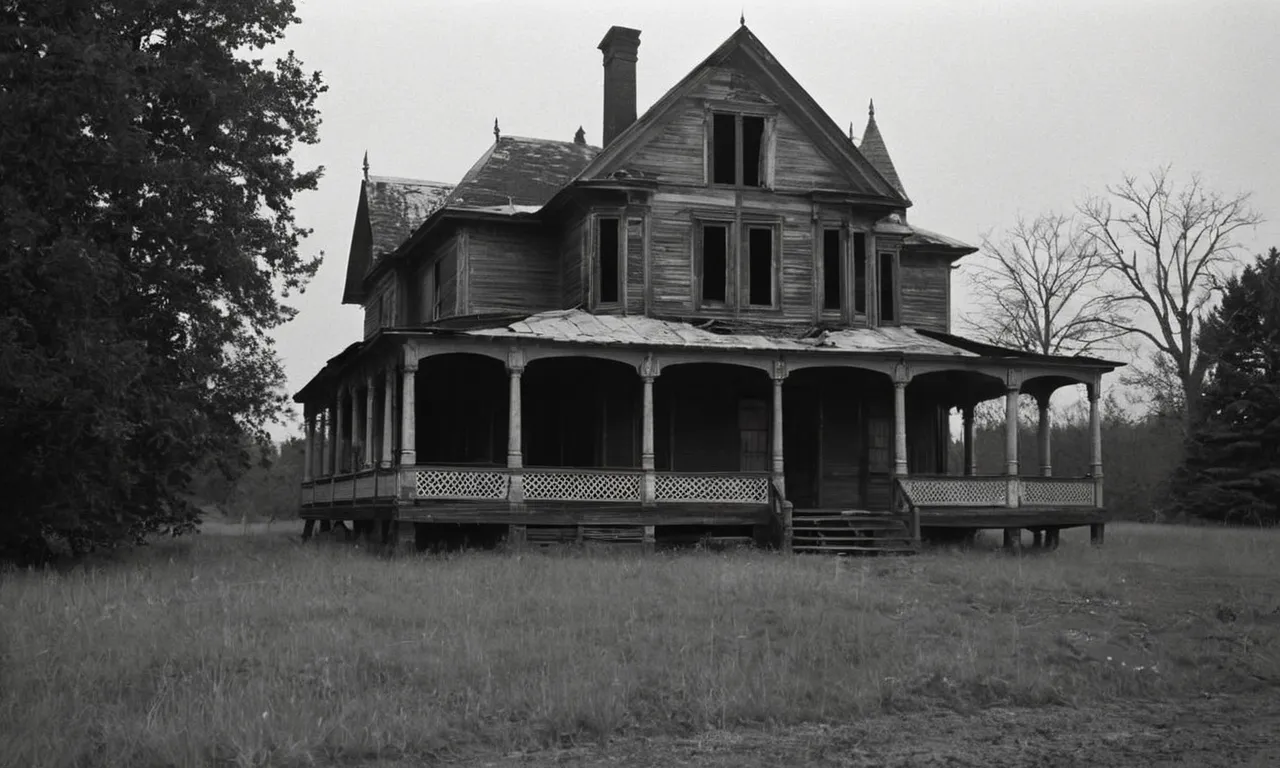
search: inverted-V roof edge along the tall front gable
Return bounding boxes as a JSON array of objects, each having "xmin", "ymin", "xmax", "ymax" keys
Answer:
[{"xmin": 579, "ymin": 24, "xmax": 911, "ymax": 207}]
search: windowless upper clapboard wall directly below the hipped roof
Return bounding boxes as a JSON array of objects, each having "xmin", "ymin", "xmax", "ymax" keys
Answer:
[{"xmin": 466, "ymin": 224, "xmax": 561, "ymax": 315}]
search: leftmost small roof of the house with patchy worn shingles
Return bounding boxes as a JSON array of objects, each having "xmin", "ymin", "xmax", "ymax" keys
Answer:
[{"xmin": 342, "ymin": 175, "xmax": 453, "ymax": 303}]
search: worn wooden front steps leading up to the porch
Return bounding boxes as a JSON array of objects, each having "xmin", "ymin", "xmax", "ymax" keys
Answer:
[{"xmin": 791, "ymin": 509, "xmax": 916, "ymax": 554}]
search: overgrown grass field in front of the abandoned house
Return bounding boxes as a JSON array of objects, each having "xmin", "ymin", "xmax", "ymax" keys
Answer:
[{"xmin": 0, "ymin": 525, "xmax": 1280, "ymax": 767}]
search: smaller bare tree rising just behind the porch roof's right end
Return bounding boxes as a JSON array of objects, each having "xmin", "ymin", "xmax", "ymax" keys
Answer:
[{"xmin": 965, "ymin": 212, "xmax": 1125, "ymax": 355}]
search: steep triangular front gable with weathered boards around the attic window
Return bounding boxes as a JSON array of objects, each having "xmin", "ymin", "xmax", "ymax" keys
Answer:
[{"xmin": 579, "ymin": 26, "xmax": 910, "ymax": 207}]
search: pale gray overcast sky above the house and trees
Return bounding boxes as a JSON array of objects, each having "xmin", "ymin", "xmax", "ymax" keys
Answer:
[{"xmin": 264, "ymin": 0, "xmax": 1280, "ymax": 436}]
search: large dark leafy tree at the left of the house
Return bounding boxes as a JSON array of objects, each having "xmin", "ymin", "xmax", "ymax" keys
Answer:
[{"xmin": 0, "ymin": 0, "xmax": 324, "ymax": 559}]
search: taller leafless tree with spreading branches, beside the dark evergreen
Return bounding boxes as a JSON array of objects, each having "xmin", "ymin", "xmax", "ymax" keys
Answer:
[{"xmin": 1080, "ymin": 168, "xmax": 1262, "ymax": 431}]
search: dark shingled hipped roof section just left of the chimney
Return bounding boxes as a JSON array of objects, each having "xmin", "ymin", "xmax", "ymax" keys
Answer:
[{"xmin": 448, "ymin": 136, "xmax": 600, "ymax": 211}]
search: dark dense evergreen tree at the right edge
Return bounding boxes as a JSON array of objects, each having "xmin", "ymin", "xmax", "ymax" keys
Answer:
[{"xmin": 1174, "ymin": 248, "xmax": 1280, "ymax": 525}]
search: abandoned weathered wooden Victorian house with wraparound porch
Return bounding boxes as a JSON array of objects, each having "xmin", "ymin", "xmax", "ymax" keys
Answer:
[{"xmin": 294, "ymin": 26, "xmax": 1116, "ymax": 552}]
